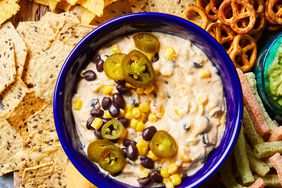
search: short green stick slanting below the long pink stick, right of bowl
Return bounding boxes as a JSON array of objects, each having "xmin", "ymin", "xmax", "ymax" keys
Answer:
[{"xmin": 243, "ymin": 107, "xmax": 264, "ymax": 146}]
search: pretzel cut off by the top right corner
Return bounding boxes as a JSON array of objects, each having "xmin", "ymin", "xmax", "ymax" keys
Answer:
[{"xmin": 266, "ymin": 0, "xmax": 282, "ymax": 24}]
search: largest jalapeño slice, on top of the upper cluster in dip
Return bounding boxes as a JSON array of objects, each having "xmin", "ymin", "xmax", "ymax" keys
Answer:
[{"xmin": 122, "ymin": 50, "xmax": 155, "ymax": 88}]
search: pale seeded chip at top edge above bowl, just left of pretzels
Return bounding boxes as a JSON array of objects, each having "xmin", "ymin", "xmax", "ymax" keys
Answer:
[{"xmin": 149, "ymin": 0, "xmax": 196, "ymax": 17}]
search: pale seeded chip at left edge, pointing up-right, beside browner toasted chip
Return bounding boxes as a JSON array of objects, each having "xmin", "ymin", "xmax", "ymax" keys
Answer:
[{"xmin": 0, "ymin": 78, "xmax": 28, "ymax": 118}]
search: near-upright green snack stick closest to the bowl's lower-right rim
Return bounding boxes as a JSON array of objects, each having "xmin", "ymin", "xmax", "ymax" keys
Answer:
[{"xmin": 234, "ymin": 127, "xmax": 255, "ymax": 184}]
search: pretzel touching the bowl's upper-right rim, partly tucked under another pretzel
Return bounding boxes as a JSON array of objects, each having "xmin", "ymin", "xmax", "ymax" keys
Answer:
[{"xmin": 206, "ymin": 22, "xmax": 235, "ymax": 53}]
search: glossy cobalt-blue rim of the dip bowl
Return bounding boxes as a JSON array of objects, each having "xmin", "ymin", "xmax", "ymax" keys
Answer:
[{"xmin": 53, "ymin": 12, "xmax": 243, "ymax": 187}]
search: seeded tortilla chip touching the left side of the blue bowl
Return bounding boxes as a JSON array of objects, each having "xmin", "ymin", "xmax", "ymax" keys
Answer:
[{"xmin": 24, "ymin": 104, "xmax": 59, "ymax": 148}]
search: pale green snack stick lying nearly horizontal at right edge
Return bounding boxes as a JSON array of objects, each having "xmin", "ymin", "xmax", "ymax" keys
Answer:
[{"xmin": 253, "ymin": 141, "xmax": 282, "ymax": 159}]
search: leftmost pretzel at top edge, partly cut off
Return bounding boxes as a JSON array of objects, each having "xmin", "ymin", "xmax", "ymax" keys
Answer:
[{"xmin": 197, "ymin": 0, "xmax": 223, "ymax": 21}]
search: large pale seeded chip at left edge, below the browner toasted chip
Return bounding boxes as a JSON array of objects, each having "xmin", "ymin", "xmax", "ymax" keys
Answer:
[{"xmin": 0, "ymin": 119, "xmax": 25, "ymax": 176}]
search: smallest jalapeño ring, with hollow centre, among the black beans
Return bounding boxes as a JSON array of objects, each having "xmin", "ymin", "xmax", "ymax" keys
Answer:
[{"xmin": 101, "ymin": 119, "xmax": 124, "ymax": 140}]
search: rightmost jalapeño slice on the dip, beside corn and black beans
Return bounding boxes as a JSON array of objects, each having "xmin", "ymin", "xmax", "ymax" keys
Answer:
[{"xmin": 150, "ymin": 130, "xmax": 178, "ymax": 158}]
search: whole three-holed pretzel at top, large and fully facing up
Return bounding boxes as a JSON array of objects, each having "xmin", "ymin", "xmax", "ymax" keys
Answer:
[{"xmin": 218, "ymin": 0, "xmax": 256, "ymax": 34}]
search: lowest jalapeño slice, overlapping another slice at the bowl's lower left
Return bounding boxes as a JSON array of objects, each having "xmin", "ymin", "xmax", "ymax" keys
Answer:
[{"xmin": 98, "ymin": 146, "xmax": 125, "ymax": 174}]
